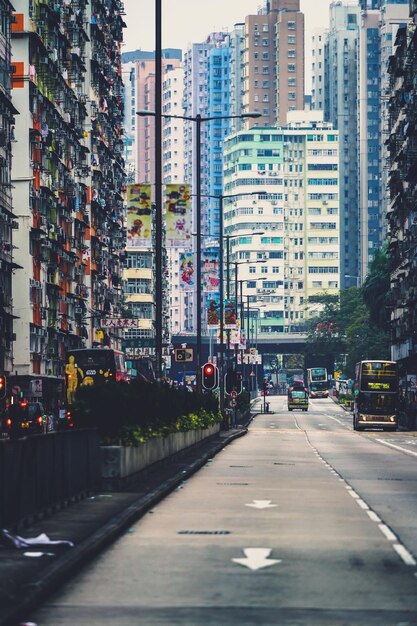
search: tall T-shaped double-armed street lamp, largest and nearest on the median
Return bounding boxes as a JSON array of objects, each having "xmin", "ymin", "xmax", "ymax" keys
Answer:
[{"xmin": 136, "ymin": 110, "xmax": 262, "ymax": 391}]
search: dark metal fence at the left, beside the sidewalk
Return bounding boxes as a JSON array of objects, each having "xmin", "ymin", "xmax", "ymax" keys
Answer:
[{"xmin": 0, "ymin": 430, "xmax": 101, "ymax": 528}]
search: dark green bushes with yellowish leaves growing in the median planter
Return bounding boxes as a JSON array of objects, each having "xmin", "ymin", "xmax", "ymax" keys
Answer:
[{"xmin": 73, "ymin": 379, "xmax": 221, "ymax": 446}]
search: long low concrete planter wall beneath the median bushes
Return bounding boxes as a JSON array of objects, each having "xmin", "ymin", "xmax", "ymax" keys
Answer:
[{"xmin": 101, "ymin": 424, "xmax": 220, "ymax": 487}]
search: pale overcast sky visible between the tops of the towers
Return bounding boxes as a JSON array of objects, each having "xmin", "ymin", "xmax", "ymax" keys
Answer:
[{"xmin": 123, "ymin": 0, "xmax": 330, "ymax": 87}]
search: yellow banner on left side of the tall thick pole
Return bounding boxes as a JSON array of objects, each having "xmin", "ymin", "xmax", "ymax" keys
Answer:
[{"xmin": 126, "ymin": 184, "xmax": 152, "ymax": 248}]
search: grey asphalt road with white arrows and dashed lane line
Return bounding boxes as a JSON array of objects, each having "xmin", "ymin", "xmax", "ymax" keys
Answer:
[{"xmin": 31, "ymin": 397, "xmax": 417, "ymax": 626}]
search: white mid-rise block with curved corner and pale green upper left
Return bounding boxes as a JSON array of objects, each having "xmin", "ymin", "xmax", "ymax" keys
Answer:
[{"xmin": 224, "ymin": 111, "xmax": 340, "ymax": 340}]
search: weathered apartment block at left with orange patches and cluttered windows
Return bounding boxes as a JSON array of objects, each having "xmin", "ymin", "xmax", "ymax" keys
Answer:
[{"xmin": 12, "ymin": 0, "xmax": 125, "ymax": 407}]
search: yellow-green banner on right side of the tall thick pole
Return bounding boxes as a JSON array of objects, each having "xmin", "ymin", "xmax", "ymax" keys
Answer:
[{"xmin": 165, "ymin": 184, "xmax": 191, "ymax": 248}]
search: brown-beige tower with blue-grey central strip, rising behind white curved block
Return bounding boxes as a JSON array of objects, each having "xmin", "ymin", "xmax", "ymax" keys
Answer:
[{"xmin": 243, "ymin": 0, "xmax": 304, "ymax": 126}]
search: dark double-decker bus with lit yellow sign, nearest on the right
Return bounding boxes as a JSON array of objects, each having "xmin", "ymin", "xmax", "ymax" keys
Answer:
[{"xmin": 353, "ymin": 361, "xmax": 399, "ymax": 430}]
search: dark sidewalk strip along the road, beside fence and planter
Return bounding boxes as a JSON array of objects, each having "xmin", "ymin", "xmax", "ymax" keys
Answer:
[{"xmin": 0, "ymin": 401, "xmax": 256, "ymax": 626}]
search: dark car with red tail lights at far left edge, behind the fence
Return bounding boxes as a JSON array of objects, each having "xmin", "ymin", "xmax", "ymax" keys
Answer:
[{"xmin": 2, "ymin": 401, "xmax": 48, "ymax": 439}]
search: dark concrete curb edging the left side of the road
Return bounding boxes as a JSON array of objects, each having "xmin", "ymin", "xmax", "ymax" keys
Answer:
[{"xmin": 0, "ymin": 427, "xmax": 248, "ymax": 626}]
